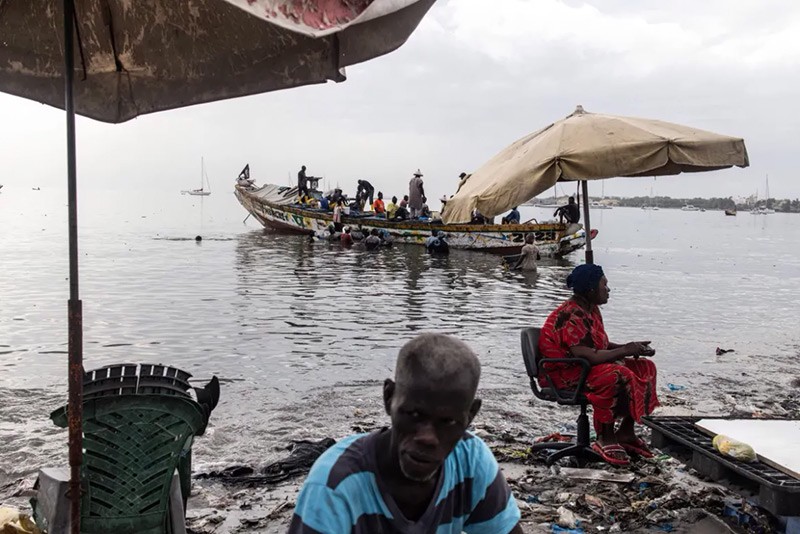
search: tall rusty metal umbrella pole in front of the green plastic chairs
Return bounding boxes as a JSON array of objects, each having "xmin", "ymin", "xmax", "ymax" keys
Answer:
[{"xmin": 64, "ymin": 0, "xmax": 83, "ymax": 534}]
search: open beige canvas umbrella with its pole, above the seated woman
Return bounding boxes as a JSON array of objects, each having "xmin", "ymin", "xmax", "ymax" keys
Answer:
[{"xmin": 444, "ymin": 106, "xmax": 749, "ymax": 261}]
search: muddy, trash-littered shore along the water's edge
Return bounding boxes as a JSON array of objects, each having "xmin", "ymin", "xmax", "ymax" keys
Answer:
[{"xmin": 0, "ymin": 347, "xmax": 784, "ymax": 534}]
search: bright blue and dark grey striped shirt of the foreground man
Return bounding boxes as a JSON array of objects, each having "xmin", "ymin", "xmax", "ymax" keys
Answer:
[{"xmin": 289, "ymin": 432, "xmax": 520, "ymax": 534}]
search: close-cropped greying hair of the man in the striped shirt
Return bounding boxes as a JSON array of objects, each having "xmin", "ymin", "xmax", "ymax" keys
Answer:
[{"xmin": 394, "ymin": 334, "xmax": 481, "ymax": 397}]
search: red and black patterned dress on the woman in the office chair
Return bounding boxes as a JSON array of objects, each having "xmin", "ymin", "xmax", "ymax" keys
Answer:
[{"xmin": 539, "ymin": 299, "xmax": 659, "ymax": 431}]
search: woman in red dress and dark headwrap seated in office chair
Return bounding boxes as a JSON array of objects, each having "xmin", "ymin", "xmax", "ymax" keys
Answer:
[{"xmin": 539, "ymin": 264, "xmax": 659, "ymax": 465}]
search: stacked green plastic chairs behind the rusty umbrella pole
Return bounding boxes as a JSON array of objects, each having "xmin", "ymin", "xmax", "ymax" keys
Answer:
[{"xmin": 31, "ymin": 365, "xmax": 218, "ymax": 534}]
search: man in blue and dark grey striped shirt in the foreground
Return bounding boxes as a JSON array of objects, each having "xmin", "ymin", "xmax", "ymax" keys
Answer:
[{"xmin": 289, "ymin": 333, "xmax": 522, "ymax": 534}]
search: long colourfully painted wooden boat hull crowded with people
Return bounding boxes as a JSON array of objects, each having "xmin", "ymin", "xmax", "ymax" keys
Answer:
[{"xmin": 234, "ymin": 184, "xmax": 586, "ymax": 257}]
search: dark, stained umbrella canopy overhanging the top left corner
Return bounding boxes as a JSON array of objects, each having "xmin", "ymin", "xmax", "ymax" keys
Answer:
[{"xmin": 0, "ymin": 0, "xmax": 435, "ymax": 123}]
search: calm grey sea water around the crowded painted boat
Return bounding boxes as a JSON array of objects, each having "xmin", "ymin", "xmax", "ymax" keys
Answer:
[{"xmin": 0, "ymin": 184, "xmax": 800, "ymax": 483}]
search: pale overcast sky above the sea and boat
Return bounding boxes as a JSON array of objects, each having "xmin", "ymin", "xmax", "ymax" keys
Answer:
[{"xmin": 0, "ymin": 0, "xmax": 800, "ymax": 205}]
